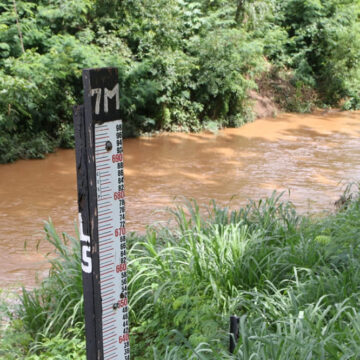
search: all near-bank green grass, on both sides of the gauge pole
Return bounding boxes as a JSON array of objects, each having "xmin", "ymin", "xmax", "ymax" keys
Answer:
[{"xmin": 0, "ymin": 190, "xmax": 360, "ymax": 360}]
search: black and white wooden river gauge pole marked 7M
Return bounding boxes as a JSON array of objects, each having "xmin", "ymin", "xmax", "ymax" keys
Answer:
[{"xmin": 74, "ymin": 68, "xmax": 130, "ymax": 360}]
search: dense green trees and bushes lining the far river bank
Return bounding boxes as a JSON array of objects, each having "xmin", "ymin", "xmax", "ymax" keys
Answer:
[{"xmin": 0, "ymin": 0, "xmax": 360, "ymax": 162}]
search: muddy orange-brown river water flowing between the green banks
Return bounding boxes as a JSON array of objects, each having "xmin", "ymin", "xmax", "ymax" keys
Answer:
[{"xmin": 0, "ymin": 112, "xmax": 360, "ymax": 288}]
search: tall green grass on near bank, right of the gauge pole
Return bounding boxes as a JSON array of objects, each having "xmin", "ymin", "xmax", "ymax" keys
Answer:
[{"xmin": 129, "ymin": 188, "xmax": 360, "ymax": 359}]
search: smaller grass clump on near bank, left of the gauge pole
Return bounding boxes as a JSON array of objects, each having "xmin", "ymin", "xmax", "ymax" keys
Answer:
[{"xmin": 0, "ymin": 221, "xmax": 85, "ymax": 360}]
